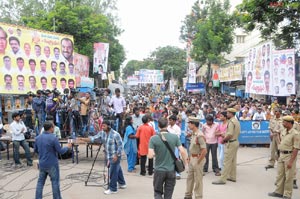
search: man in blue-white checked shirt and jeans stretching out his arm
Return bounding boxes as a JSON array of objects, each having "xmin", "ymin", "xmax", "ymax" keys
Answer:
[{"xmin": 78, "ymin": 120, "xmax": 126, "ymax": 195}]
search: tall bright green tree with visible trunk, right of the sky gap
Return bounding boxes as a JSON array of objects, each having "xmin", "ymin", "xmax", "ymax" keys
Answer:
[{"xmin": 191, "ymin": 0, "xmax": 235, "ymax": 79}]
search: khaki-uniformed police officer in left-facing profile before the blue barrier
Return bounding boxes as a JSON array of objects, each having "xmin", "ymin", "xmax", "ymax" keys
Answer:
[{"xmin": 212, "ymin": 108, "xmax": 241, "ymax": 185}]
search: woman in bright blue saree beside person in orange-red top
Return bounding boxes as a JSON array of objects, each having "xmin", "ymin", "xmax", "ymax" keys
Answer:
[{"xmin": 123, "ymin": 116, "xmax": 137, "ymax": 172}]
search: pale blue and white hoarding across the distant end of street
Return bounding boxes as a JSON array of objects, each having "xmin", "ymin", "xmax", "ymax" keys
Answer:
[{"xmin": 139, "ymin": 69, "xmax": 164, "ymax": 84}]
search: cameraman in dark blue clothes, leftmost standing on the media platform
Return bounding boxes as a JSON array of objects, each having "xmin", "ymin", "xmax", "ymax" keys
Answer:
[{"xmin": 32, "ymin": 90, "xmax": 46, "ymax": 135}]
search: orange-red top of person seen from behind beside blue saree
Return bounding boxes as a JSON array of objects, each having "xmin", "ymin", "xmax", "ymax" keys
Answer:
[{"xmin": 136, "ymin": 124, "xmax": 155, "ymax": 155}]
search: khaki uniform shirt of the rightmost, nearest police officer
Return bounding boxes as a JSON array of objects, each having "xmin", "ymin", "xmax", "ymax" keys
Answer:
[{"xmin": 278, "ymin": 128, "xmax": 300, "ymax": 151}]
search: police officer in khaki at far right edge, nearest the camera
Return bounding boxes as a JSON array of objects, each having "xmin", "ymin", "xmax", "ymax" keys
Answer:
[{"xmin": 268, "ymin": 116, "xmax": 300, "ymax": 199}]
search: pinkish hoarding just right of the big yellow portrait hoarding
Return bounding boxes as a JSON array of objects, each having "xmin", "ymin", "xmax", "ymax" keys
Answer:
[{"xmin": 74, "ymin": 53, "xmax": 94, "ymax": 87}]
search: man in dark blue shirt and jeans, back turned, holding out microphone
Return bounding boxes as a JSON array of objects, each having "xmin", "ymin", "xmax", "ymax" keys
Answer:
[{"xmin": 34, "ymin": 121, "xmax": 72, "ymax": 199}]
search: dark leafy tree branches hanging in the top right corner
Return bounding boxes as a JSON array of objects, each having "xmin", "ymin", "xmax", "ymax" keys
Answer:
[{"xmin": 235, "ymin": 0, "xmax": 300, "ymax": 48}]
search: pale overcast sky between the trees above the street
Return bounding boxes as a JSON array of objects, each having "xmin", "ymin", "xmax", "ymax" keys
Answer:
[{"xmin": 117, "ymin": 0, "xmax": 195, "ymax": 61}]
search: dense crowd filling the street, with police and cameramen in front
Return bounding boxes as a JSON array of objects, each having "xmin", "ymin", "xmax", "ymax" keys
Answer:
[{"xmin": 0, "ymin": 89, "xmax": 300, "ymax": 199}]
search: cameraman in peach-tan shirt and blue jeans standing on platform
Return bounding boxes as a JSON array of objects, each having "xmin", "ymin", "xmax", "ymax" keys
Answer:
[{"xmin": 78, "ymin": 92, "xmax": 91, "ymax": 136}]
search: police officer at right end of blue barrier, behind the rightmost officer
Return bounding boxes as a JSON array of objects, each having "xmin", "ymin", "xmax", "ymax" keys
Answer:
[{"xmin": 265, "ymin": 108, "xmax": 283, "ymax": 169}]
